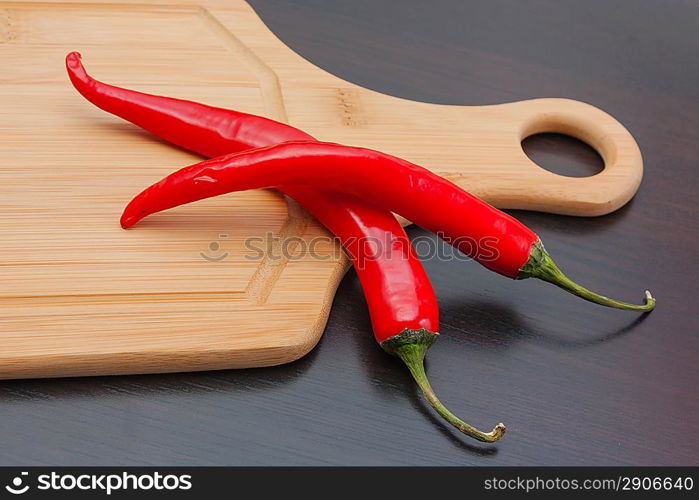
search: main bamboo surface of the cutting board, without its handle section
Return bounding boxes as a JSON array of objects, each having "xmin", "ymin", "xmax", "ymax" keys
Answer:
[{"xmin": 0, "ymin": 2, "xmax": 346, "ymax": 378}]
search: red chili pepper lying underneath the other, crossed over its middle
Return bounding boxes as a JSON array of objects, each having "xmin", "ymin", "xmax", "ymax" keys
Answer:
[{"xmin": 66, "ymin": 52, "xmax": 505, "ymax": 442}]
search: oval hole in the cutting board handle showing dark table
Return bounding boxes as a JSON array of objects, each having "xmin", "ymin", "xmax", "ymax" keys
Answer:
[{"xmin": 522, "ymin": 133, "xmax": 604, "ymax": 177}]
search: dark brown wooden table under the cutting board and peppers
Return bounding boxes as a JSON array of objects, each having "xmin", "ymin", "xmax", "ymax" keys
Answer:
[{"xmin": 0, "ymin": 0, "xmax": 699, "ymax": 465}]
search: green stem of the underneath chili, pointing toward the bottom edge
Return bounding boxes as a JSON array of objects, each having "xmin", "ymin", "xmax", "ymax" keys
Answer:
[{"xmin": 381, "ymin": 330, "xmax": 505, "ymax": 443}]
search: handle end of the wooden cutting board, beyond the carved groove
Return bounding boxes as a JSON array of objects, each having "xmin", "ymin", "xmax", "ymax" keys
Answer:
[{"xmin": 209, "ymin": 2, "xmax": 643, "ymax": 216}]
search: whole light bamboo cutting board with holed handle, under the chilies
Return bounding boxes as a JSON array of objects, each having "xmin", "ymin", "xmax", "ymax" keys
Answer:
[{"xmin": 0, "ymin": 0, "xmax": 642, "ymax": 378}]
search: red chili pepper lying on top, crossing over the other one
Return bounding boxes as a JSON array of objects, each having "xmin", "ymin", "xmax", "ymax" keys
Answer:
[{"xmin": 121, "ymin": 141, "xmax": 655, "ymax": 312}]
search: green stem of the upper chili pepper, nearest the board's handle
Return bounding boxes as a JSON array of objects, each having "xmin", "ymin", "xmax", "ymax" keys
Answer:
[{"xmin": 517, "ymin": 240, "xmax": 655, "ymax": 312}]
